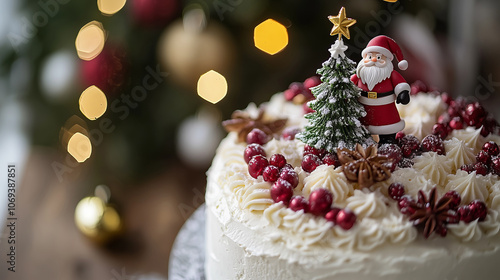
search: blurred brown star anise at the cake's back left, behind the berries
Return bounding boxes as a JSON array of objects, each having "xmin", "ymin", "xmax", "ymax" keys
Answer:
[{"xmin": 222, "ymin": 108, "xmax": 287, "ymax": 142}]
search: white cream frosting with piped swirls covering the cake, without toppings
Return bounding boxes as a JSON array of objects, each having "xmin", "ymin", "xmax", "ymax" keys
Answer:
[{"xmin": 205, "ymin": 91, "xmax": 500, "ymax": 280}]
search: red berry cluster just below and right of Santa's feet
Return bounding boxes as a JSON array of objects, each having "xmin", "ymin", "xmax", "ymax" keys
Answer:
[{"xmin": 377, "ymin": 131, "xmax": 445, "ymax": 172}]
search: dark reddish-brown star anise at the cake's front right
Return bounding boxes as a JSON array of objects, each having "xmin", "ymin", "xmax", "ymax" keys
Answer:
[{"xmin": 409, "ymin": 187, "xmax": 456, "ymax": 238}]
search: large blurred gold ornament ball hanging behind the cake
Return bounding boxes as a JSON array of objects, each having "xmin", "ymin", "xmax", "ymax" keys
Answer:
[{"xmin": 158, "ymin": 21, "xmax": 235, "ymax": 89}]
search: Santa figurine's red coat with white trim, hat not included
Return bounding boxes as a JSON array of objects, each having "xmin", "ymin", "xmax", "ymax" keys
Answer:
[{"xmin": 351, "ymin": 70, "xmax": 410, "ymax": 134}]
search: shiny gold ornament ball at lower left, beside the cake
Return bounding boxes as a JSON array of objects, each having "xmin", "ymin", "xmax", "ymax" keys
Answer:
[{"xmin": 75, "ymin": 196, "xmax": 123, "ymax": 244}]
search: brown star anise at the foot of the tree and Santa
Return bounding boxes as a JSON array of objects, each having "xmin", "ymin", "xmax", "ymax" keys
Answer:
[{"xmin": 337, "ymin": 144, "xmax": 391, "ymax": 188}]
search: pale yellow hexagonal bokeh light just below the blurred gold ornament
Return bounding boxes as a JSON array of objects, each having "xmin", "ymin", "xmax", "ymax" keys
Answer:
[{"xmin": 198, "ymin": 70, "xmax": 227, "ymax": 104}]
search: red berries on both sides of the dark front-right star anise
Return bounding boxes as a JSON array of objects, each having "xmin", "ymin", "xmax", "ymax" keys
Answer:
[{"xmin": 388, "ymin": 183, "xmax": 488, "ymax": 236}]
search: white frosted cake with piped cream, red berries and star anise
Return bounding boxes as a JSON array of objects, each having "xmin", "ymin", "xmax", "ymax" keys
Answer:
[{"xmin": 205, "ymin": 86, "xmax": 500, "ymax": 280}]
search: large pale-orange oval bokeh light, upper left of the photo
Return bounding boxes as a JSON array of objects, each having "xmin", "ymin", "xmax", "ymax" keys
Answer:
[{"xmin": 75, "ymin": 21, "xmax": 106, "ymax": 60}]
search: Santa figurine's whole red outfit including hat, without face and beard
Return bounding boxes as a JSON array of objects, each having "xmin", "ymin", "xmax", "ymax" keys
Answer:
[{"xmin": 351, "ymin": 35, "xmax": 410, "ymax": 134}]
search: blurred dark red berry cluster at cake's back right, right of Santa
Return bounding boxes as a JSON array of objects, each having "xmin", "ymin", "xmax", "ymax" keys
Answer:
[{"xmin": 432, "ymin": 93, "xmax": 498, "ymax": 139}]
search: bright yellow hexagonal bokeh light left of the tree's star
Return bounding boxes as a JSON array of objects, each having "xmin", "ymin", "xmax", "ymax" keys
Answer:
[{"xmin": 254, "ymin": 19, "xmax": 288, "ymax": 55}]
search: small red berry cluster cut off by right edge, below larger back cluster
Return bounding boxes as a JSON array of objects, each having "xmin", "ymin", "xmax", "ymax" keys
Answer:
[{"xmin": 460, "ymin": 141, "xmax": 500, "ymax": 175}]
